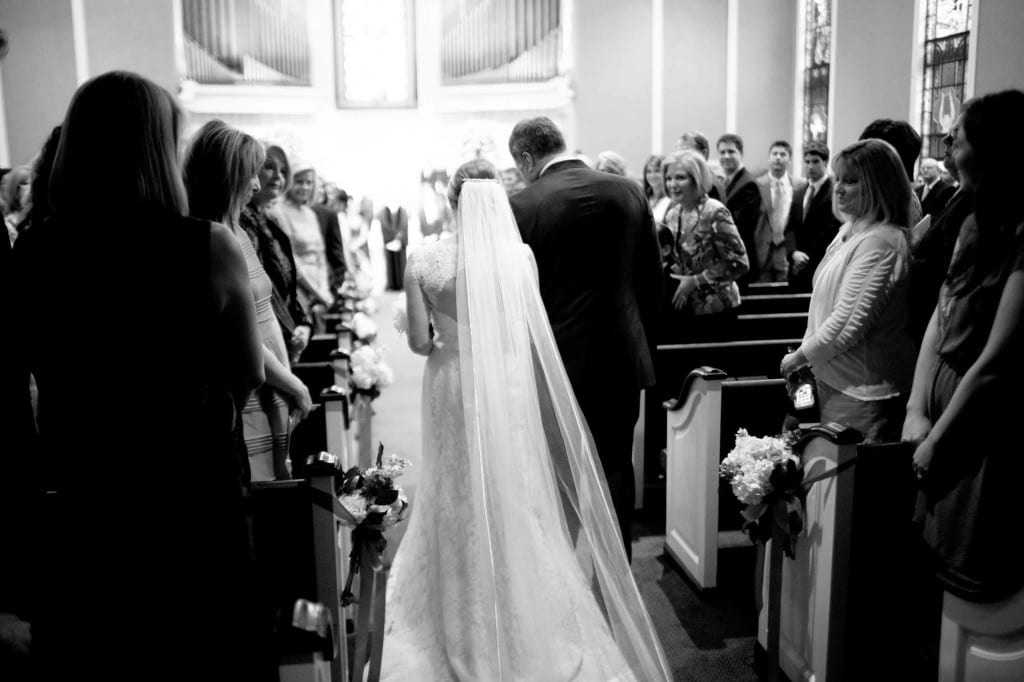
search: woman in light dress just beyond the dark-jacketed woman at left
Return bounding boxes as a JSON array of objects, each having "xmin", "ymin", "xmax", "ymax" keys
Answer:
[{"xmin": 274, "ymin": 159, "xmax": 334, "ymax": 334}]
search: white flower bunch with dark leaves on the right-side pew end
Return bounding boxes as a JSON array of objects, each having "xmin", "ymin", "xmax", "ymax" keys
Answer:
[{"xmin": 719, "ymin": 429, "xmax": 806, "ymax": 559}]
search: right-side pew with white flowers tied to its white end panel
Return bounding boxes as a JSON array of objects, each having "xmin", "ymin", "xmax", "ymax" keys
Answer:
[{"xmin": 758, "ymin": 424, "xmax": 934, "ymax": 682}]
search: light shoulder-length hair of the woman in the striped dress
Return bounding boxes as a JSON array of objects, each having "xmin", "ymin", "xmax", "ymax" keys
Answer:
[{"xmin": 183, "ymin": 120, "xmax": 265, "ymax": 223}]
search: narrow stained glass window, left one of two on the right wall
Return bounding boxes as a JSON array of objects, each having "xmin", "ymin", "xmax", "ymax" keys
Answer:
[{"xmin": 804, "ymin": 0, "xmax": 831, "ymax": 142}]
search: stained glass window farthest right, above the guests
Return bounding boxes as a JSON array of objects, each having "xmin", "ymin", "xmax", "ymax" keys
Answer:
[{"xmin": 921, "ymin": 0, "xmax": 971, "ymax": 159}]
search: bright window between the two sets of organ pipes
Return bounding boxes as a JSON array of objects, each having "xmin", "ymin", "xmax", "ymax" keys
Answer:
[{"xmin": 335, "ymin": 0, "xmax": 416, "ymax": 106}]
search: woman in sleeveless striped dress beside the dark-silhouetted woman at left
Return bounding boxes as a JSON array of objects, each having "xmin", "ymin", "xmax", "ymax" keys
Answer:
[{"xmin": 183, "ymin": 121, "xmax": 312, "ymax": 480}]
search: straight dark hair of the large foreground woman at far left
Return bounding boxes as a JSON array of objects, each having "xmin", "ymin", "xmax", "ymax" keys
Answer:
[{"xmin": 50, "ymin": 71, "xmax": 188, "ymax": 215}]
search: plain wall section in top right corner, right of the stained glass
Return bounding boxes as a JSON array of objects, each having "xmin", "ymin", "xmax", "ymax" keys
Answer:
[{"xmin": 974, "ymin": 0, "xmax": 1024, "ymax": 95}]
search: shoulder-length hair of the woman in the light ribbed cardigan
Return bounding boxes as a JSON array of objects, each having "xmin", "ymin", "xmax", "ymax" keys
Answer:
[{"xmin": 833, "ymin": 138, "xmax": 911, "ymax": 228}]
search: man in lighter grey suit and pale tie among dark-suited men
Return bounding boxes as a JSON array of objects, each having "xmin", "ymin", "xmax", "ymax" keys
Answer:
[{"xmin": 746, "ymin": 139, "xmax": 807, "ymax": 282}]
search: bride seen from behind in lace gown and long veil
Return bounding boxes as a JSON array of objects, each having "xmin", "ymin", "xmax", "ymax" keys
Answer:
[{"xmin": 382, "ymin": 160, "xmax": 671, "ymax": 682}]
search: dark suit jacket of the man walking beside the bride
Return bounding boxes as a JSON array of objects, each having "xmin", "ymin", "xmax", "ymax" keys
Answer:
[{"xmin": 509, "ymin": 161, "xmax": 662, "ymax": 392}]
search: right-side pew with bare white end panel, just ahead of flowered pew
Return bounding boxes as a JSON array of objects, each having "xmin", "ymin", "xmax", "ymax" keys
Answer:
[{"xmin": 664, "ymin": 367, "xmax": 791, "ymax": 589}]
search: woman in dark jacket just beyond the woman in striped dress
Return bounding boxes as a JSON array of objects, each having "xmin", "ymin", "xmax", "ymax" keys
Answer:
[{"xmin": 239, "ymin": 144, "xmax": 312, "ymax": 365}]
